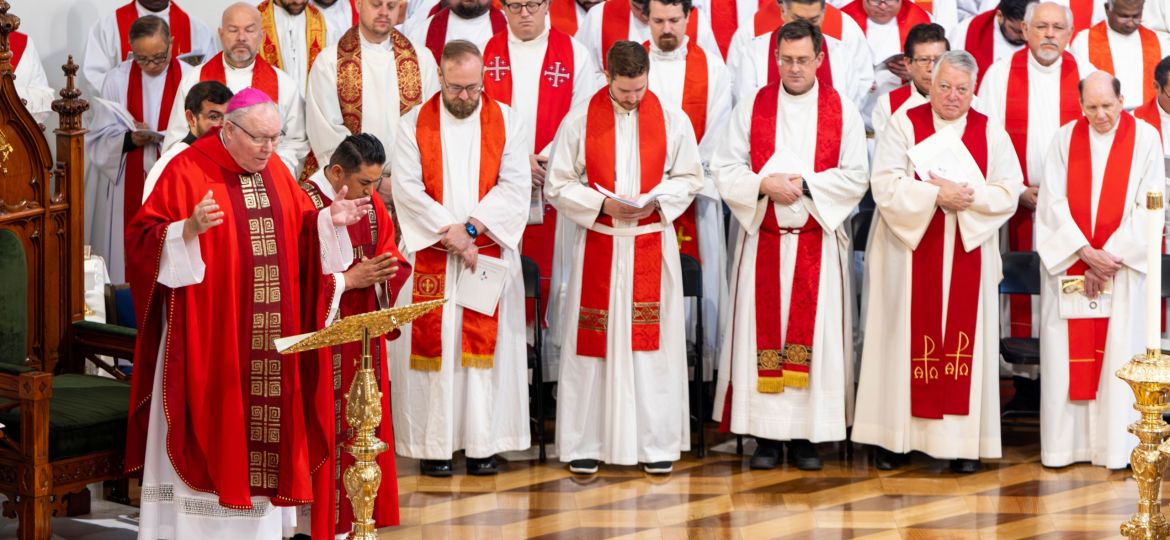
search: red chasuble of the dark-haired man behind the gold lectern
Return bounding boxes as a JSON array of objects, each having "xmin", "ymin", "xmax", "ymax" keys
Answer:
[{"xmin": 301, "ymin": 180, "xmax": 411, "ymax": 538}]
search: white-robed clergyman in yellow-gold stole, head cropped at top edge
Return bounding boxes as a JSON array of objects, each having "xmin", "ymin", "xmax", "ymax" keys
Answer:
[{"xmin": 256, "ymin": 0, "xmax": 337, "ymax": 95}]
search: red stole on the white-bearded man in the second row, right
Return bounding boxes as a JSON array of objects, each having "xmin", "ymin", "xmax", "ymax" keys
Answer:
[{"xmin": 1004, "ymin": 48, "xmax": 1081, "ymax": 338}]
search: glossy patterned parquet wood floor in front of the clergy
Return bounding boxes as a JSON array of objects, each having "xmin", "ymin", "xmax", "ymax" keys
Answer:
[{"xmin": 379, "ymin": 425, "xmax": 1137, "ymax": 540}]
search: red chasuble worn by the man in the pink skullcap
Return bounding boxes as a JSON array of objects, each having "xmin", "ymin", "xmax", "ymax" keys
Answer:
[{"xmin": 125, "ymin": 129, "xmax": 333, "ymax": 510}]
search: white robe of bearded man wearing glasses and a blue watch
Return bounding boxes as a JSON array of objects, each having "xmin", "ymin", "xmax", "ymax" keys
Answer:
[{"xmin": 388, "ymin": 98, "xmax": 532, "ymax": 459}]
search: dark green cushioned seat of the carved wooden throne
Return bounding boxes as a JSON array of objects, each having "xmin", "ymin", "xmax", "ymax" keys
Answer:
[{"xmin": 0, "ymin": 374, "xmax": 130, "ymax": 461}]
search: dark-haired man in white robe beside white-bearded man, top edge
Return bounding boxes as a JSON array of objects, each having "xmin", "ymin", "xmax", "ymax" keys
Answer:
[{"xmin": 948, "ymin": 0, "xmax": 1038, "ymax": 89}]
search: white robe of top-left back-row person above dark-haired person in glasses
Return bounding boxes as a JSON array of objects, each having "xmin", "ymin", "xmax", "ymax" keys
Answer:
[{"xmin": 82, "ymin": 1, "xmax": 220, "ymax": 90}]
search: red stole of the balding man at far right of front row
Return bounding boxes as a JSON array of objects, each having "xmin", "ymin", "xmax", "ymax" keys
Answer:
[{"xmin": 1067, "ymin": 112, "xmax": 1137, "ymax": 400}]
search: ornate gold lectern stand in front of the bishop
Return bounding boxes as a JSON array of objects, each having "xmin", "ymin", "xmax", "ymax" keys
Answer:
[{"xmin": 277, "ymin": 299, "xmax": 447, "ymax": 540}]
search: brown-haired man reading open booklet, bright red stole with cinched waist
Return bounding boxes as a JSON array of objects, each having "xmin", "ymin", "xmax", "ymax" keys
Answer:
[{"xmin": 544, "ymin": 41, "xmax": 703, "ymax": 475}]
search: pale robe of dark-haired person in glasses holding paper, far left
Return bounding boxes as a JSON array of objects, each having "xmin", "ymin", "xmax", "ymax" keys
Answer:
[{"xmin": 85, "ymin": 60, "xmax": 191, "ymax": 283}]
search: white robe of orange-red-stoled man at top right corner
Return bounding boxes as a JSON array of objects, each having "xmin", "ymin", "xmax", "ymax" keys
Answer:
[{"xmin": 1068, "ymin": 25, "xmax": 1170, "ymax": 110}]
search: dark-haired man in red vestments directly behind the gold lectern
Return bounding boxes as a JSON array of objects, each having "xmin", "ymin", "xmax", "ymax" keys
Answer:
[{"xmin": 297, "ymin": 133, "xmax": 411, "ymax": 538}]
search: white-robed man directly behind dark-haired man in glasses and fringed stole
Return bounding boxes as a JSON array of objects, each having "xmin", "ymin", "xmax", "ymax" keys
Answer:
[{"xmin": 728, "ymin": 0, "xmax": 874, "ymax": 109}]
